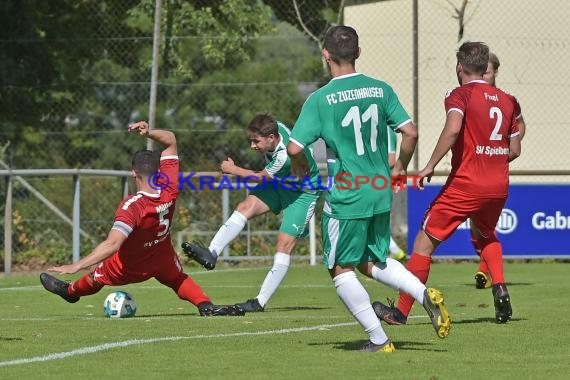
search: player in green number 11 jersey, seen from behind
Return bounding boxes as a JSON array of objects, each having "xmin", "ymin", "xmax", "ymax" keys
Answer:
[{"xmin": 287, "ymin": 26, "xmax": 451, "ymax": 352}]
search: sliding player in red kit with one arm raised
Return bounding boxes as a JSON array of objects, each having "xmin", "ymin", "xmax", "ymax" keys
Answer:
[{"xmin": 40, "ymin": 121, "xmax": 245, "ymax": 316}]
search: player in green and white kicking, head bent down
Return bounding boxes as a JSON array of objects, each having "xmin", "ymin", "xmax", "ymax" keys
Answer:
[{"xmin": 183, "ymin": 113, "xmax": 324, "ymax": 312}]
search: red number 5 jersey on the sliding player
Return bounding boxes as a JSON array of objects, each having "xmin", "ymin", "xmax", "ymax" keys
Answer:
[{"xmin": 113, "ymin": 156, "xmax": 179, "ymax": 269}]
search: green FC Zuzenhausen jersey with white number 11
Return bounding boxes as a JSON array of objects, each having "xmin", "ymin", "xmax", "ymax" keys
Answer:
[{"xmin": 290, "ymin": 73, "xmax": 411, "ymax": 219}]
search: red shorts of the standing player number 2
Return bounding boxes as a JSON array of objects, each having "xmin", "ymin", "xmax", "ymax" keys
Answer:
[{"xmin": 422, "ymin": 187, "xmax": 507, "ymax": 241}]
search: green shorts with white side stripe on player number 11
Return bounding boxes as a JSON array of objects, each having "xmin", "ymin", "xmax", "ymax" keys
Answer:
[{"xmin": 321, "ymin": 212, "xmax": 390, "ymax": 269}]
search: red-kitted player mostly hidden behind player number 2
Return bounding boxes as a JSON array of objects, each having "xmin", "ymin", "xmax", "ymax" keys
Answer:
[{"xmin": 470, "ymin": 53, "xmax": 526, "ymax": 289}]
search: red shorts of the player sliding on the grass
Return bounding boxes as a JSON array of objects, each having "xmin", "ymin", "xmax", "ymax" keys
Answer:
[{"xmin": 93, "ymin": 249, "xmax": 184, "ymax": 286}]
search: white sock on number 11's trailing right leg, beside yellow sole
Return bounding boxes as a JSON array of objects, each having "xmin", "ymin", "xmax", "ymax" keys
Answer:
[{"xmin": 372, "ymin": 257, "xmax": 426, "ymax": 304}]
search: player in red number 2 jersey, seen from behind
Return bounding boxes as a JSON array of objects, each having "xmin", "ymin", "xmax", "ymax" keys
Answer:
[{"xmin": 373, "ymin": 42, "xmax": 521, "ymax": 324}]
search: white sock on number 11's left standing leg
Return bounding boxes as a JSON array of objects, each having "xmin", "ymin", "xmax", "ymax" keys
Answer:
[{"xmin": 333, "ymin": 271, "xmax": 388, "ymax": 344}]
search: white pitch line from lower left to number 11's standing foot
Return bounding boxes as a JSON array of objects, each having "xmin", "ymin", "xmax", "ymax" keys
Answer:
[{"xmin": 0, "ymin": 322, "xmax": 357, "ymax": 367}]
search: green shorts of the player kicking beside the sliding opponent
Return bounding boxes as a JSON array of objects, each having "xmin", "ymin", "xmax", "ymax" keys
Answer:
[{"xmin": 250, "ymin": 188, "xmax": 320, "ymax": 238}]
